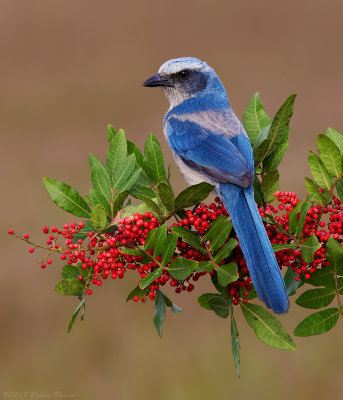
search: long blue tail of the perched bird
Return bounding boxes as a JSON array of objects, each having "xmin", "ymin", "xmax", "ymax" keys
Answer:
[{"xmin": 217, "ymin": 183, "xmax": 289, "ymax": 314}]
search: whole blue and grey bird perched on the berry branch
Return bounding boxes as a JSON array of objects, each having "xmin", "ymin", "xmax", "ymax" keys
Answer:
[{"xmin": 143, "ymin": 57, "xmax": 289, "ymax": 314}]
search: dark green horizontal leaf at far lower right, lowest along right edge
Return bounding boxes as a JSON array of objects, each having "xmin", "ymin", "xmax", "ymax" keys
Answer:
[{"xmin": 294, "ymin": 308, "xmax": 339, "ymax": 336}]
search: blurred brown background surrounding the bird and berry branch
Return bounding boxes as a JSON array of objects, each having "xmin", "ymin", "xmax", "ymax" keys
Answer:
[{"xmin": 0, "ymin": 0, "xmax": 343, "ymax": 400}]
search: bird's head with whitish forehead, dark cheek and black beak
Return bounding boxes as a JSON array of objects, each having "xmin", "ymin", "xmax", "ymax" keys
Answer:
[{"xmin": 143, "ymin": 57, "xmax": 226, "ymax": 107}]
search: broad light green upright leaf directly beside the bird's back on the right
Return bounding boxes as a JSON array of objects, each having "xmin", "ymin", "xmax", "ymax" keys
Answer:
[{"xmin": 243, "ymin": 93, "xmax": 271, "ymax": 146}]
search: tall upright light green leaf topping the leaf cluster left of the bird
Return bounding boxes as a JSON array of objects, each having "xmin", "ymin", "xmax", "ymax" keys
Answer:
[{"xmin": 106, "ymin": 130, "xmax": 127, "ymax": 185}]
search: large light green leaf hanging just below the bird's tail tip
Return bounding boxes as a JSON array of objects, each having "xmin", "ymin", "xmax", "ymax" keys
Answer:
[{"xmin": 240, "ymin": 303, "xmax": 296, "ymax": 350}]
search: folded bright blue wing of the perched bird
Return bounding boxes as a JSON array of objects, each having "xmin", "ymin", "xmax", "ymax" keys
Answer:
[{"xmin": 167, "ymin": 117, "xmax": 254, "ymax": 187}]
